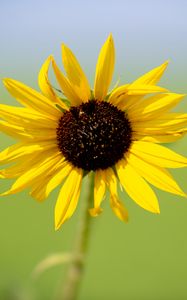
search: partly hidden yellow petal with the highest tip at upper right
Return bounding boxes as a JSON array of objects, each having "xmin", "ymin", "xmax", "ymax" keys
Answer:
[{"xmin": 131, "ymin": 61, "xmax": 168, "ymax": 85}]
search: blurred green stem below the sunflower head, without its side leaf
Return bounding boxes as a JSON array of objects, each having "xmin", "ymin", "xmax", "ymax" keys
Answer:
[{"xmin": 61, "ymin": 174, "xmax": 94, "ymax": 300}]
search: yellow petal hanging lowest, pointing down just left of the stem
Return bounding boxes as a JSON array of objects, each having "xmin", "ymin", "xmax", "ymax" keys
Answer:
[{"xmin": 55, "ymin": 168, "xmax": 83, "ymax": 230}]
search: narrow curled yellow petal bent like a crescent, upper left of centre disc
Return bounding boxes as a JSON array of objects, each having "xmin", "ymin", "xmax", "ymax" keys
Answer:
[{"xmin": 38, "ymin": 56, "xmax": 68, "ymax": 110}]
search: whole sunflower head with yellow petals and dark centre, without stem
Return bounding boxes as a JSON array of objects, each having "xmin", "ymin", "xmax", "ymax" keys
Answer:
[{"xmin": 0, "ymin": 35, "xmax": 187, "ymax": 229}]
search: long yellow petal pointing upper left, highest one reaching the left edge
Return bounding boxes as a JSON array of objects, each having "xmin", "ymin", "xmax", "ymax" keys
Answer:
[{"xmin": 3, "ymin": 78, "xmax": 61, "ymax": 120}]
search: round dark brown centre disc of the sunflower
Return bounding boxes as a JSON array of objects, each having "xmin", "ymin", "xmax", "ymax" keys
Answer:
[{"xmin": 57, "ymin": 100, "xmax": 132, "ymax": 171}]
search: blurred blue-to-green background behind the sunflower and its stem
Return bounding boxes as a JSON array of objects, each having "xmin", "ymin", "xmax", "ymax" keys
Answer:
[{"xmin": 0, "ymin": 0, "xmax": 187, "ymax": 300}]
